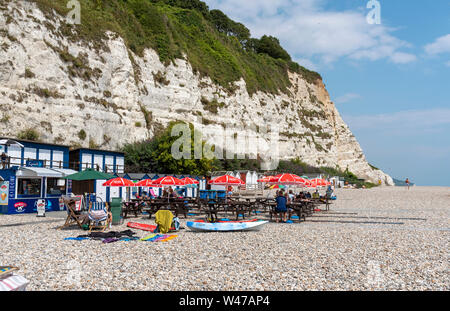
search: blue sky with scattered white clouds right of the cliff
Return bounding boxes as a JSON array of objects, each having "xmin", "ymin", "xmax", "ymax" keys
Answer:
[{"xmin": 205, "ymin": 0, "xmax": 450, "ymax": 186}]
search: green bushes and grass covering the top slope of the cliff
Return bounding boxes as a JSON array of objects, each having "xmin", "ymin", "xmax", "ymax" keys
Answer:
[{"xmin": 31, "ymin": 0, "xmax": 321, "ymax": 94}]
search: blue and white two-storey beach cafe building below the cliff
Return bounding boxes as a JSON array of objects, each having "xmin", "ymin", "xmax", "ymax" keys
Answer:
[{"xmin": 0, "ymin": 137, "xmax": 124, "ymax": 214}]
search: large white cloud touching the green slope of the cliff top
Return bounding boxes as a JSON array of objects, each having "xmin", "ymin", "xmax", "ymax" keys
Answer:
[{"xmin": 206, "ymin": 0, "xmax": 416, "ymax": 64}]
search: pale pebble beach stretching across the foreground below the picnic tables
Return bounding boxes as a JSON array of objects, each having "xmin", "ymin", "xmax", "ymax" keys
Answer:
[{"xmin": 0, "ymin": 187, "xmax": 450, "ymax": 291}]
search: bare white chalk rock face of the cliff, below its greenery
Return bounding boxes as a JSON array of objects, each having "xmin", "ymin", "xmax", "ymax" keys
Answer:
[{"xmin": 0, "ymin": 1, "xmax": 394, "ymax": 185}]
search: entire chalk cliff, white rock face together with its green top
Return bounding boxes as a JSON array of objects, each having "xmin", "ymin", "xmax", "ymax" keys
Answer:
[{"xmin": 0, "ymin": 0, "xmax": 394, "ymax": 185}]
